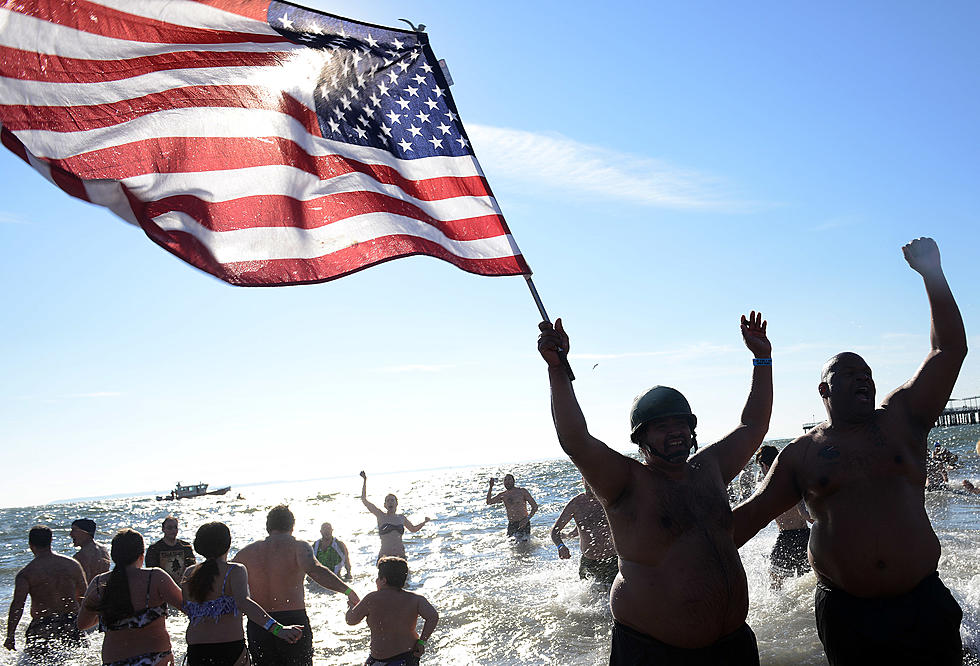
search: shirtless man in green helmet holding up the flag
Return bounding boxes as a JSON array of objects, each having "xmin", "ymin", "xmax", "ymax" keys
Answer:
[{"xmin": 538, "ymin": 312, "xmax": 772, "ymax": 666}]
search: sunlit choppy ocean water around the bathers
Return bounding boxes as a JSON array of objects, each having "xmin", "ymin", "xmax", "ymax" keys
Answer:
[{"xmin": 0, "ymin": 426, "xmax": 980, "ymax": 666}]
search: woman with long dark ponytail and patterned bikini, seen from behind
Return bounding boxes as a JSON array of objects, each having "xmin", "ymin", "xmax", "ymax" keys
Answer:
[{"xmin": 78, "ymin": 528, "xmax": 183, "ymax": 666}]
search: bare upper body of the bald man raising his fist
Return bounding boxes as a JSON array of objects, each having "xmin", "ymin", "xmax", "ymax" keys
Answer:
[{"xmin": 734, "ymin": 238, "xmax": 967, "ymax": 598}]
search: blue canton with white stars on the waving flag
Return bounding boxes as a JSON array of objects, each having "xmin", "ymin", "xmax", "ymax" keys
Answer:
[{"xmin": 267, "ymin": 2, "xmax": 473, "ymax": 160}]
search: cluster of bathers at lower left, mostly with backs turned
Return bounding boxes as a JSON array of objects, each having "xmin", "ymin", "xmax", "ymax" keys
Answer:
[{"xmin": 4, "ymin": 505, "xmax": 439, "ymax": 666}]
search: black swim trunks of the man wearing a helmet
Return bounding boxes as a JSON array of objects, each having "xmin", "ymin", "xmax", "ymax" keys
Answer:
[{"xmin": 609, "ymin": 622, "xmax": 759, "ymax": 666}]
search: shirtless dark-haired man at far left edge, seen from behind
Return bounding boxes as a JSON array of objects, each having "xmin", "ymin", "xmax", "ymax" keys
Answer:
[{"xmin": 3, "ymin": 525, "xmax": 85, "ymax": 663}]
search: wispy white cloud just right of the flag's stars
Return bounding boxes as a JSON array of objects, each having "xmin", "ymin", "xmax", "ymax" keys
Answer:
[{"xmin": 468, "ymin": 125, "xmax": 759, "ymax": 212}]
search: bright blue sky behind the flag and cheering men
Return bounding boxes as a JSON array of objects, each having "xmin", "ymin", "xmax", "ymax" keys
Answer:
[{"xmin": 0, "ymin": 0, "xmax": 980, "ymax": 506}]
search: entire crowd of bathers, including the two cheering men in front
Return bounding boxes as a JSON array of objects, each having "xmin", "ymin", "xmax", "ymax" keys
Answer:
[{"xmin": 6, "ymin": 238, "xmax": 975, "ymax": 666}]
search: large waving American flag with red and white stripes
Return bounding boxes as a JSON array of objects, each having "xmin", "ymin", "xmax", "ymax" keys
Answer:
[{"xmin": 0, "ymin": 0, "xmax": 530, "ymax": 286}]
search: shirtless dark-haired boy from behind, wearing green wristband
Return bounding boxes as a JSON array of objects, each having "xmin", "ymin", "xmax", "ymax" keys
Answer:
[{"xmin": 346, "ymin": 557, "xmax": 439, "ymax": 666}]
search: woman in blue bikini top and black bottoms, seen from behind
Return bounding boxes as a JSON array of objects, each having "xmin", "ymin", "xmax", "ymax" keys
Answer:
[{"xmin": 181, "ymin": 523, "xmax": 303, "ymax": 666}]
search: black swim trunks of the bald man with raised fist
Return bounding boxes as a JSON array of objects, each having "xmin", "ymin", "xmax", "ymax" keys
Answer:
[{"xmin": 813, "ymin": 573, "xmax": 963, "ymax": 666}]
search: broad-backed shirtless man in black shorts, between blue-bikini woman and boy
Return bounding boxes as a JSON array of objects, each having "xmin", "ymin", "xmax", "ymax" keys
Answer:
[{"xmin": 233, "ymin": 504, "xmax": 358, "ymax": 666}]
